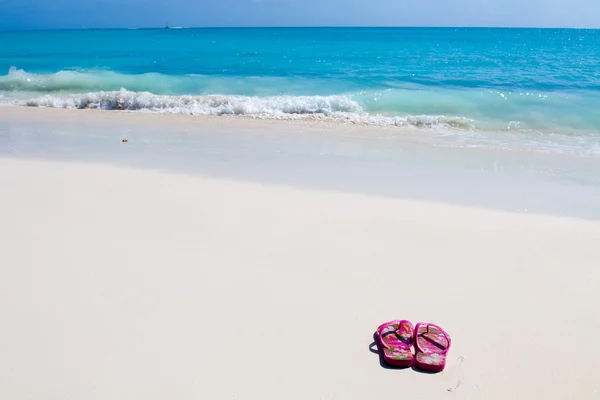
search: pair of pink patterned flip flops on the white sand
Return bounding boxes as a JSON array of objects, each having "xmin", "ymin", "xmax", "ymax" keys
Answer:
[{"xmin": 376, "ymin": 320, "xmax": 451, "ymax": 372}]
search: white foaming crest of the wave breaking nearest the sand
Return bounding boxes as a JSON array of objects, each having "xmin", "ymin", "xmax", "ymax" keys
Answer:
[{"xmin": 17, "ymin": 89, "xmax": 472, "ymax": 129}]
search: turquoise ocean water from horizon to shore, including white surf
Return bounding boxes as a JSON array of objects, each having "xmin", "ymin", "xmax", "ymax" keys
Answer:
[{"xmin": 0, "ymin": 28, "xmax": 600, "ymax": 156}]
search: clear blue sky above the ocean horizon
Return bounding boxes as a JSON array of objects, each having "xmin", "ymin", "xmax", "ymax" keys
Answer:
[{"xmin": 0, "ymin": 0, "xmax": 600, "ymax": 30}]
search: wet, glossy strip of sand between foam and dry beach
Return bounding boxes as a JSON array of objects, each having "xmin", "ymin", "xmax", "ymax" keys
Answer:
[{"xmin": 0, "ymin": 107, "xmax": 600, "ymax": 219}]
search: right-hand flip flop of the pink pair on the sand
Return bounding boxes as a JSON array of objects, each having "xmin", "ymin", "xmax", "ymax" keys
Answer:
[{"xmin": 414, "ymin": 322, "xmax": 451, "ymax": 372}]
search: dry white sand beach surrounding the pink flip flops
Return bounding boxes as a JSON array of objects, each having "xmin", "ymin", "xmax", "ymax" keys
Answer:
[{"xmin": 0, "ymin": 110, "xmax": 600, "ymax": 400}]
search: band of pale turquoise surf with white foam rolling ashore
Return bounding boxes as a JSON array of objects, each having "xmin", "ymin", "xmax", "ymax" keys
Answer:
[{"xmin": 7, "ymin": 68, "xmax": 600, "ymax": 134}]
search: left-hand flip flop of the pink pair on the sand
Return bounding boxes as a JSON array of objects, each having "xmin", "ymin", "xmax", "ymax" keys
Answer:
[{"xmin": 377, "ymin": 319, "xmax": 414, "ymax": 367}]
